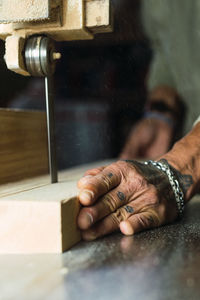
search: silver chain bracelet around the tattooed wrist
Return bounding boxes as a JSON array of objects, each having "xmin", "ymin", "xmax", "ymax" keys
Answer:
[{"xmin": 144, "ymin": 160, "xmax": 184, "ymax": 216}]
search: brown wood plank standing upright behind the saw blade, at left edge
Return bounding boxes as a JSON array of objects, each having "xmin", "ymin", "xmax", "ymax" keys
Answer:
[{"xmin": 0, "ymin": 109, "xmax": 48, "ymax": 184}]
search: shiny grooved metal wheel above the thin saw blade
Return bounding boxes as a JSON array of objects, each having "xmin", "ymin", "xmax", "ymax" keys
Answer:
[{"xmin": 25, "ymin": 36, "xmax": 61, "ymax": 77}]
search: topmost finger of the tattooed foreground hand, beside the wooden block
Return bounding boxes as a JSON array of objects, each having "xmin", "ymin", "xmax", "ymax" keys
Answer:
[{"xmin": 78, "ymin": 164, "xmax": 121, "ymax": 206}]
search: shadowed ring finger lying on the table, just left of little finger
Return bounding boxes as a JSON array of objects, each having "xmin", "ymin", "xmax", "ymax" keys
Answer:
[{"xmin": 82, "ymin": 207, "xmax": 136, "ymax": 241}]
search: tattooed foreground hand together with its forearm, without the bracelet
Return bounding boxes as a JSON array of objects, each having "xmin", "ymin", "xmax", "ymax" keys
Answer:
[{"xmin": 78, "ymin": 116, "xmax": 200, "ymax": 240}]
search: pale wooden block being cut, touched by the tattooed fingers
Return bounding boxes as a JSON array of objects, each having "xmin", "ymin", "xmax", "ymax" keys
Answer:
[{"xmin": 0, "ymin": 181, "xmax": 81, "ymax": 254}]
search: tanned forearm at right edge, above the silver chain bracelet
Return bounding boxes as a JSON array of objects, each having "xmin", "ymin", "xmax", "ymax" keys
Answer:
[{"xmin": 159, "ymin": 122, "xmax": 200, "ymax": 202}]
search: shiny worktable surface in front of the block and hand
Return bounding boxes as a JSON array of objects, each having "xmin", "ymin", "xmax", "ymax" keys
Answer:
[{"xmin": 0, "ymin": 199, "xmax": 200, "ymax": 300}]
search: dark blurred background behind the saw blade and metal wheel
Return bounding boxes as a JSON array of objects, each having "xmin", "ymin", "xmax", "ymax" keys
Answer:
[{"xmin": 0, "ymin": 0, "xmax": 152, "ymax": 168}]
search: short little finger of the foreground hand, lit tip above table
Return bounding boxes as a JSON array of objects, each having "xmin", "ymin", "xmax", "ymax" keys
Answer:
[{"xmin": 120, "ymin": 210, "xmax": 161, "ymax": 235}]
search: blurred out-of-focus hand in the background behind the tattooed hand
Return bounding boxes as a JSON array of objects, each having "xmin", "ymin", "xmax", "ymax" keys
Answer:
[{"xmin": 120, "ymin": 119, "xmax": 174, "ymax": 159}]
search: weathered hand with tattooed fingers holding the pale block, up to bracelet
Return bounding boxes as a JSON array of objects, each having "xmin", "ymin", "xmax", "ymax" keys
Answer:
[{"xmin": 78, "ymin": 161, "xmax": 177, "ymax": 240}]
